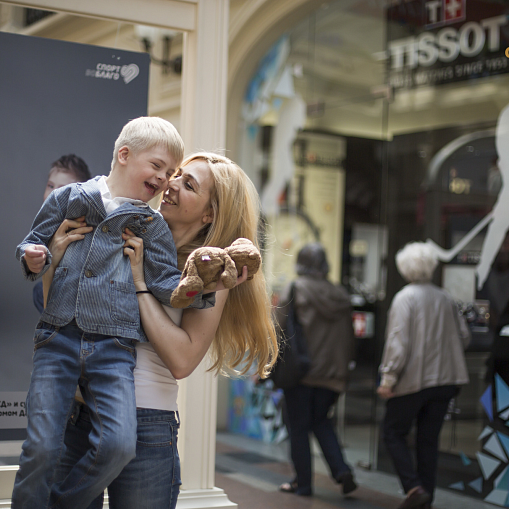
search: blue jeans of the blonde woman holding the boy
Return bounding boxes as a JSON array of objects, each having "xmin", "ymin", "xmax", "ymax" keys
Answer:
[{"xmin": 59, "ymin": 403, "xmax": 181, "ymax": 509}]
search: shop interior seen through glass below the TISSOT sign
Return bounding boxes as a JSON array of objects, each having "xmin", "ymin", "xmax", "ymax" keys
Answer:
[{"xmin": 233, "ymin": 1, "xmax": 509, "ymax": 497}]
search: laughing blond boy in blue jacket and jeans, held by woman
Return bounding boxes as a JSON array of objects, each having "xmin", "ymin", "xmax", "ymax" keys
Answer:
[{"xmin": 12, "ymin": 117, "xmax": 209, "ymax": 509}]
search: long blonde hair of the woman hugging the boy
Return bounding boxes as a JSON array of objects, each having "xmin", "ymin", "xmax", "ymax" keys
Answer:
[{"xmin": 178, "ymin": 152, "xmax": 278, "ymax": 378}]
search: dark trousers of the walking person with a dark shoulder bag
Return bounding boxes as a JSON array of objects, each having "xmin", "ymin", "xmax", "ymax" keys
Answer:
[{"xmin": 284, "ymin": 385, "xmax": 350, "ymax": 495}]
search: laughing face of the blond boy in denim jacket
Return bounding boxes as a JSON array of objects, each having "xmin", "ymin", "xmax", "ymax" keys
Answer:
[{"xmin": 116, "ymin": 145, "xmax": 176, "ymax": 202}]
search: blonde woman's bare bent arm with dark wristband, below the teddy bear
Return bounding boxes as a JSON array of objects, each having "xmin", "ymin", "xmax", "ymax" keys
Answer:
[{"xmin": 123, "ymin": 230, "xmax": 247, "ymax": 380}]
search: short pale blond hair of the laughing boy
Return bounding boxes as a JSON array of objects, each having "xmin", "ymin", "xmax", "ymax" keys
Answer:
[{"xmin": 111, "ymin": 117, "xmax": 184, "ymax": 170}]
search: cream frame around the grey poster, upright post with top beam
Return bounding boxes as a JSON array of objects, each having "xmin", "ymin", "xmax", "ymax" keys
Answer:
[{"xmin": 0, "ymin": 0, "xmax": 232, "ymax": 509}]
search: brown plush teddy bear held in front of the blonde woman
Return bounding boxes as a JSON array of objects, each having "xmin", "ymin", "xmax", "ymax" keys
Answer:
[{"xmin": 170, "ymin": 238, "xmax": 262, "ymax": 308}]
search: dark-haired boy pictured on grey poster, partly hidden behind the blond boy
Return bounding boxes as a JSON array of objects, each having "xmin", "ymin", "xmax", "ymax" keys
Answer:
[{"xmin": 32, "ymin": 154, "xmax": 92, "ymax": 313}]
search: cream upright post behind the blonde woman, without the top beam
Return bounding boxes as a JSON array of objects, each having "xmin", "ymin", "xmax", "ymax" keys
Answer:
[{"xmin": 178, "ymin": 0, "xmax": 233, "ymax": 509}]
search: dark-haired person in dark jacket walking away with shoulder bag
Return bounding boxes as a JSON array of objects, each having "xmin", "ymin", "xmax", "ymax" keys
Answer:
[{"xmin": 278, "ymin": 243, "xmax": 357, "ymax": 496}]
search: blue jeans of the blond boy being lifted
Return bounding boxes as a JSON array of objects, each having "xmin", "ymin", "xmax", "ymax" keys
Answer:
[{"xmin": 12, "ymin": 321, "xmax": 136, "ymax": 509}]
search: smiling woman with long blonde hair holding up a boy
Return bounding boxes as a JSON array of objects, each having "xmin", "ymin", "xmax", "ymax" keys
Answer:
[{"xmin": 45, "ymin": 153, "xmax": 277, "ymax": 509}]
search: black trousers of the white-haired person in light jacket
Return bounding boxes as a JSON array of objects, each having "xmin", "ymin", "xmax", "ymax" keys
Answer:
[{"xmin": 383, "ymin": 385, "xmax": 458, "ymax": 495}]
